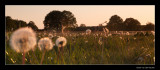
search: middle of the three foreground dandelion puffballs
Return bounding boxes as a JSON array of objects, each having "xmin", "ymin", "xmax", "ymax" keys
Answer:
[{"xmin": 38, "ymin": 37, "xmax": 54, "ymax": 51}]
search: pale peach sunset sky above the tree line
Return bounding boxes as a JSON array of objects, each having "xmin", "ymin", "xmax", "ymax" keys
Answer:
[{"xmin": 5, "ymin": 5, "xmax": 155, "ymax": 29}]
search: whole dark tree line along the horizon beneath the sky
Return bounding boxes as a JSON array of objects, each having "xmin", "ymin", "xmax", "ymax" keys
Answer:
[{"xmin": 6, "ymin": 10, "xmax": 155, "ymax": 33}]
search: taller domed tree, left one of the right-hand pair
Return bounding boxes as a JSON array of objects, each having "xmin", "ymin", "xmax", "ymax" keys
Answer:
[{"xmin": 107, "ymin": 15, "xmax": 123, "ymax": 30}]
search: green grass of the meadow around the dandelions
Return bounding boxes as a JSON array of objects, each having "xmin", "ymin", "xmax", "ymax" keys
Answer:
[{"xmin": 5, "ymin": 33, "xmax": 155, "ymax": 64}]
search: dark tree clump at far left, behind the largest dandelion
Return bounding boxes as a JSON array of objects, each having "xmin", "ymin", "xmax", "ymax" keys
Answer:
[{"xmin": 6, "ymin": 16, "xmax": 27, "ymax": 31}]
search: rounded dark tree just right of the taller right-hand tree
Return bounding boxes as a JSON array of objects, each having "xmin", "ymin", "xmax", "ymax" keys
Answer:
[{"xmin": 124, "ymin": 18, "xmax": 141, "ymax": 31}]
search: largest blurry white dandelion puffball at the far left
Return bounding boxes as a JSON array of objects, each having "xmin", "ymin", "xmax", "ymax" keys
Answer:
[{"xmin": 10, "ymin": 27, "xmax": 36, "ymax": 52}]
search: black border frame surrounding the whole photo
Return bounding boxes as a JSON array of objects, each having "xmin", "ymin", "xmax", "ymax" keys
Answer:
[{"xmin": 0, "ymin": 0, "xmax": 160, "ymax": 70}]
